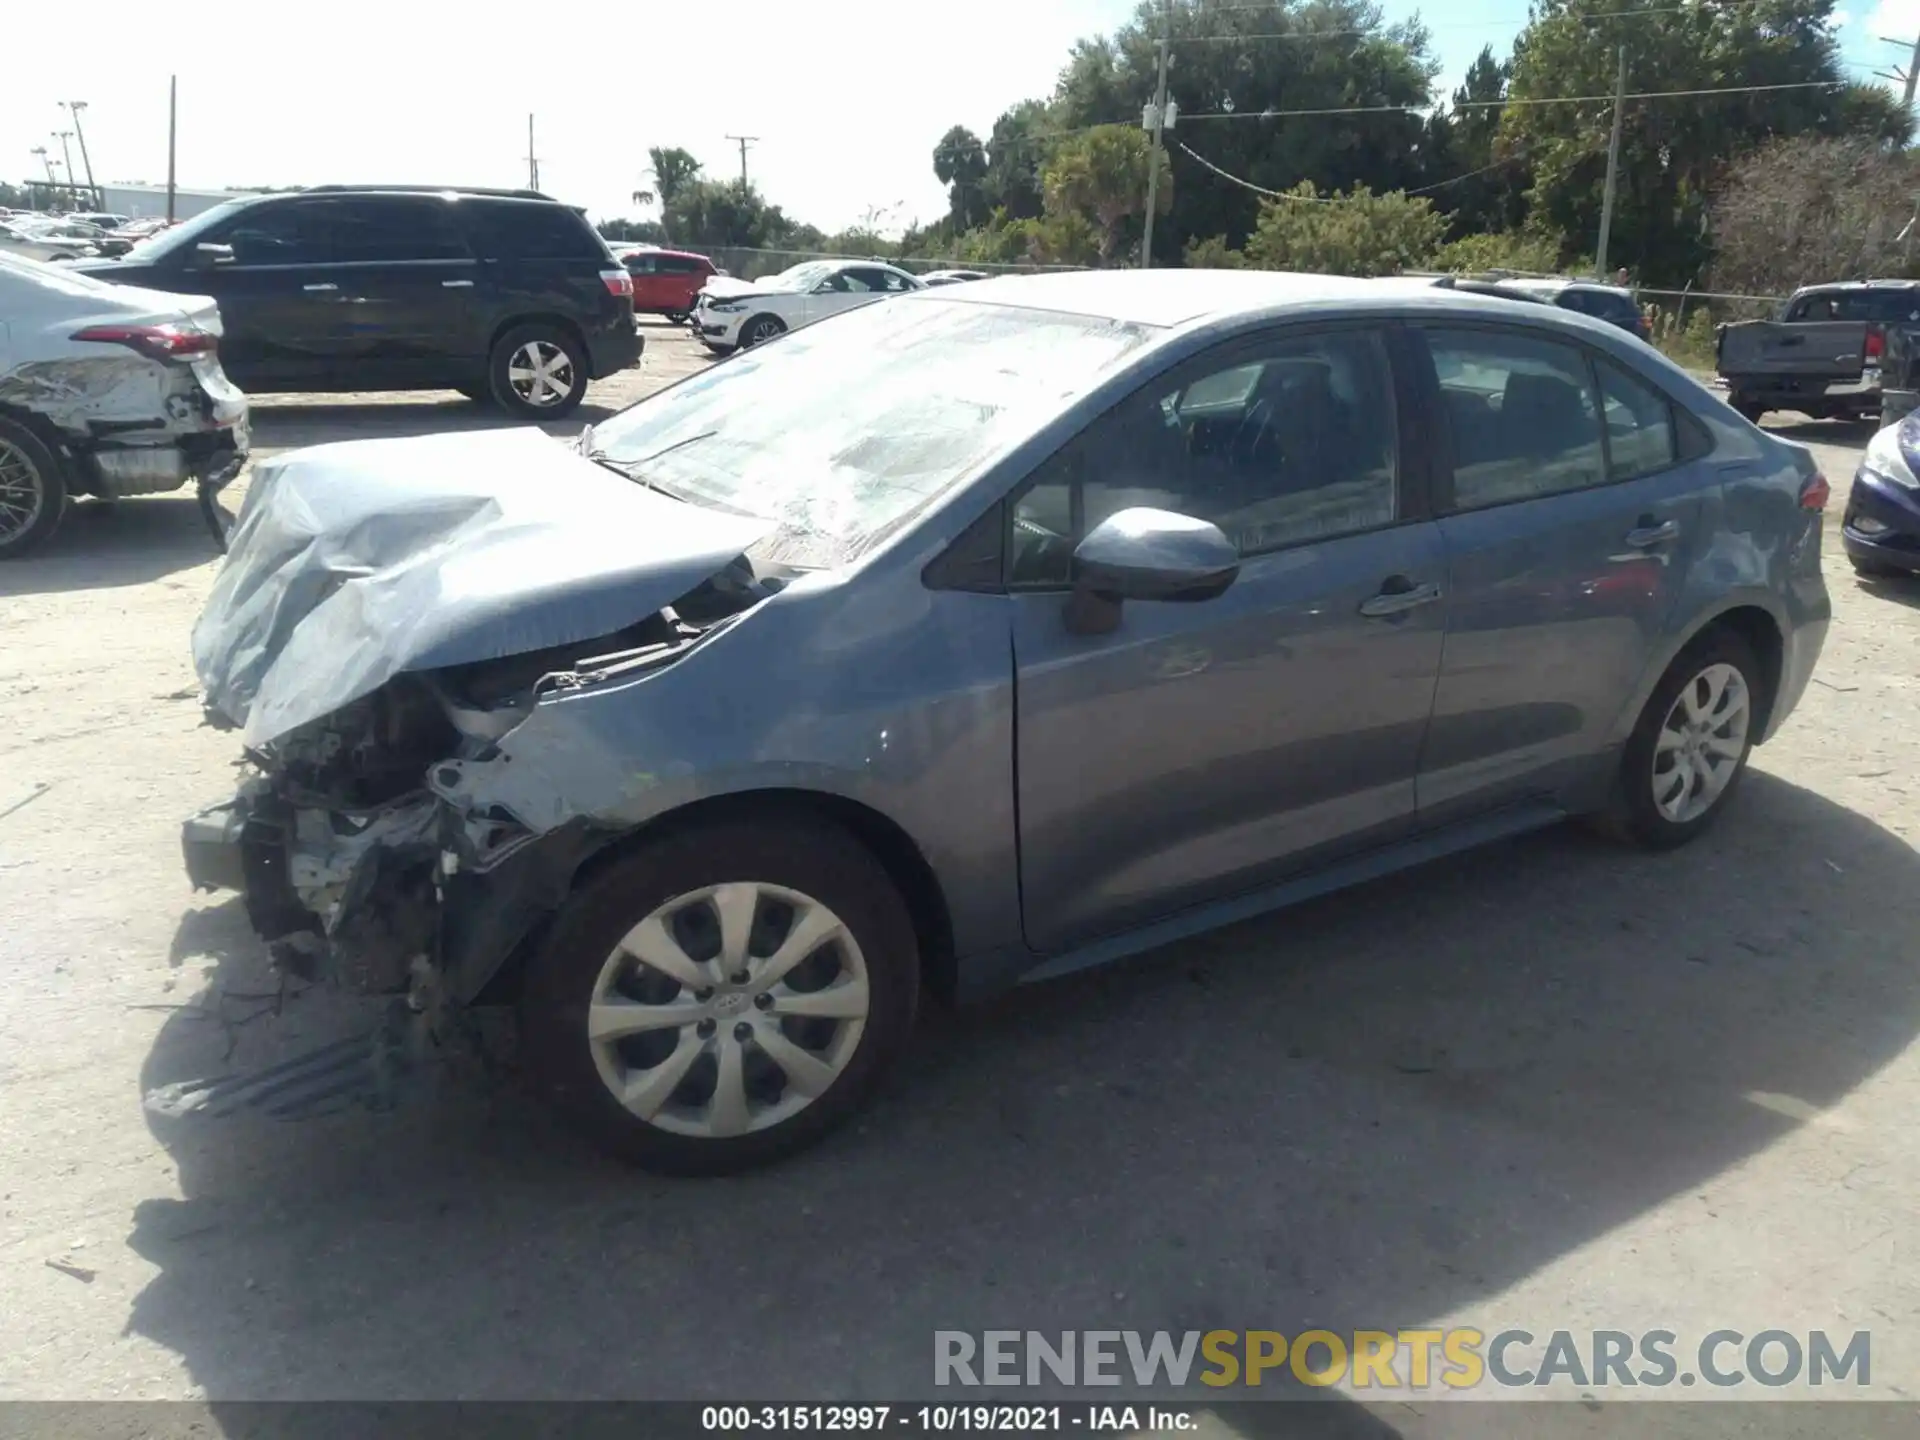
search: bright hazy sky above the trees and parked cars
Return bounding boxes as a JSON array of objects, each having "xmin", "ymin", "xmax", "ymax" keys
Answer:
[{"xmin": 0, "ymin": 0, "xmax": 1920, "ymax": 230}]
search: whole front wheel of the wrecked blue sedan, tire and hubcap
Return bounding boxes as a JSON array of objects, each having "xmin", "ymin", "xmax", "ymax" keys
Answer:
[{"xmin": 520, "ymin": 816, "xmax": 920, "ymax": 1175}]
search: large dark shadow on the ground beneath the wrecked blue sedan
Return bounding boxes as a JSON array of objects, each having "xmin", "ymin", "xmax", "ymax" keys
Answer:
[{"xmin": 127, "ymin": 772, "xmax": 1920, "ymax": 1413}]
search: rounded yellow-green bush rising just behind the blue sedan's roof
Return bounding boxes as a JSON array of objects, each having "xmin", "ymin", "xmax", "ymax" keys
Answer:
[{"xmin": 1246, "ymin": 180, "xmax": 1446, "ymax": 275}]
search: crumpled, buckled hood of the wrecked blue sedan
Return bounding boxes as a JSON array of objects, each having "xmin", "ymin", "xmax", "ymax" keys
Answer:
[{"xmin": 194, "ymin": 428, "xmax": 774, "ymax": 745}]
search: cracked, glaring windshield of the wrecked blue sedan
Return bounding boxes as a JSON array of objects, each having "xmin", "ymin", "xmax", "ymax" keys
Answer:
[{"xmin": 589, "ymin": 298, "xmax": 1154, "ymax": 568}]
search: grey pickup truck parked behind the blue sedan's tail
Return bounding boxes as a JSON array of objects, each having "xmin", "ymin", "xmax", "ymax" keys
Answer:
[{"xmin": 1715, "ymin": 280, "xmax": 1920, "ymax": 420}]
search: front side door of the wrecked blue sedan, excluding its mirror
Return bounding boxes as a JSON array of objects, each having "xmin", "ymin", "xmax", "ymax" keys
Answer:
[{"xmin": 1010, "ymin": 328, "xmax": 1446, "ymax": 950}]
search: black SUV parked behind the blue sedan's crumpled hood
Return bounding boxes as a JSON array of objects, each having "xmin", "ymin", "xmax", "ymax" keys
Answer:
[{"xmin": 73, "ymin": 184, "xmax": 641, "ymax": 419}]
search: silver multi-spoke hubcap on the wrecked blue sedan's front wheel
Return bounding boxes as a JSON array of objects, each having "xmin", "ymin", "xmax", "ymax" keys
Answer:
[{"xmin": 588, "ymin": 883, "xmax": 868, "ymax": 1139}]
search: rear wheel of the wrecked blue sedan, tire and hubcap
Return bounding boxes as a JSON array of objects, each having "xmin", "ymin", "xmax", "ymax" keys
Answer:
[{"xmin": 1603, "ymin": 630, "xmax": 1764, "ymax": 851}]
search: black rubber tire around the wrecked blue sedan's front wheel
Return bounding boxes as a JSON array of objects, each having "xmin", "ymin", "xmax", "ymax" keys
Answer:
[{"xmin": 520, "ymin": 814, "xmax": 920, "ymax": 1175}]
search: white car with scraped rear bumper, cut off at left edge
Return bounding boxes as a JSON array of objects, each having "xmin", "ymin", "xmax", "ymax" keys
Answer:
[{"xmin": 0, "ymin": 253, "xmax": 248, "ymax": 559}]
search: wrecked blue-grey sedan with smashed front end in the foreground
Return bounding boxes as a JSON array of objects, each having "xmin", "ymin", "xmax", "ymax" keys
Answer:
[{"xmin": 184, "ymin": 271, "xmax": 1830, "ymax": 1173}]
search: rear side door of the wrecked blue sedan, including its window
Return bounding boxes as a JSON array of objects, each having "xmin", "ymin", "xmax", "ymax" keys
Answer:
[{"xmin": 1419, "ymin": 326, "xmax": 1711, "ymax": 824}]
